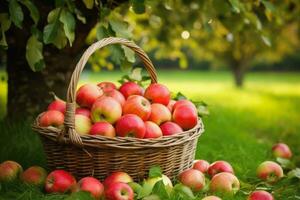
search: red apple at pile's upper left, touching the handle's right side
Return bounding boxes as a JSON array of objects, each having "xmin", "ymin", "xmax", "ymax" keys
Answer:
[{"xmin": 76, "ymin": 84, "xmax": 103, "ymax": 108}]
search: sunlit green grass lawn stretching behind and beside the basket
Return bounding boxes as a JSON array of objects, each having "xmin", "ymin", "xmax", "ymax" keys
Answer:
[{"xmin": 0, "ymin": 71, "xmax": 300, "ymax": 199}]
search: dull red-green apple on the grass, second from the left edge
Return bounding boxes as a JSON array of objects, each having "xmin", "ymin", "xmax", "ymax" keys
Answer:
[{"xmin": 20, "ymin": 166, "xmax": 47, "ymax": 186}]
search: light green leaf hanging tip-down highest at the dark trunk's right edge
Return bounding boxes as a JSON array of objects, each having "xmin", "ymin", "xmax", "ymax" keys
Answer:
[{"xmin": 59, "ymin": 9, "xmax": 76, "ymax": 46}]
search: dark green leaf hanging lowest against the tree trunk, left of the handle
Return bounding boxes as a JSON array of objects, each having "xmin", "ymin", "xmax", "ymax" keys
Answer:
[{"xmin": 26, "ymin": 35, "xmax": 45, "ymax": 71}]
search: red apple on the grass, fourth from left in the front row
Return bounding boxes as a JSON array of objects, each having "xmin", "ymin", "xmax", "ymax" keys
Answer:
[{"xmin": 73, "ymin": 177, "xmax": 104, "ymax": 200}]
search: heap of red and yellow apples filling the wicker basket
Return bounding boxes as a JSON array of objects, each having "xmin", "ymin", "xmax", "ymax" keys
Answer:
[{"xmin": 39, "ymin": 81, "xmax": 198, "ymax": 138}]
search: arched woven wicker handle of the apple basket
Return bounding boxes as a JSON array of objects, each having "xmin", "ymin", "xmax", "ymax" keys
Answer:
[{"xmin": 62, "ymin": 37, "xmax": 157, "ymax": 146}]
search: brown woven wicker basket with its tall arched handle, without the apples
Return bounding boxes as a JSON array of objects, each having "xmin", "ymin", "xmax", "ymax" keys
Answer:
[{"xmin": 33, "ymin": 37, "xmax": 204, "ymax": 181}]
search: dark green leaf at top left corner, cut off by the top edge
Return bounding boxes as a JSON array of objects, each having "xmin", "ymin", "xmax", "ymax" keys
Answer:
[{"xmin": 8, "ymin": 0, "xmax": 24, "ymax": 28}]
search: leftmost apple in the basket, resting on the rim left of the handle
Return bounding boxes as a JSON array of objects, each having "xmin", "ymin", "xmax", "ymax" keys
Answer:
[{"xmin": 39, "ymin": 110, "xmax": 65, "ymax": 127}]
